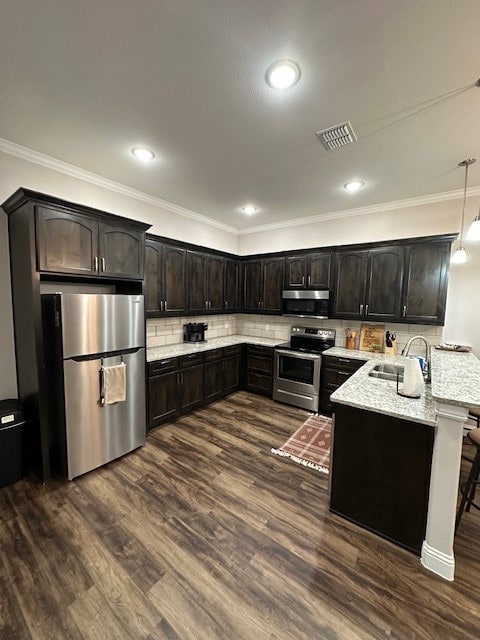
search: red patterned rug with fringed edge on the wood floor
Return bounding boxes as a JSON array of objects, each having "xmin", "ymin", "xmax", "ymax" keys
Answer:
[{"xmin": 272, "ymin": 415, "xmax": 332, "ymax": 473}]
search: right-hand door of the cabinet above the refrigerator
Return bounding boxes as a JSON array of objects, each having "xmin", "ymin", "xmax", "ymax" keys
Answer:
[{"xmin": 99, "ymin": 222, "xmax": 145, "ymax": 280}]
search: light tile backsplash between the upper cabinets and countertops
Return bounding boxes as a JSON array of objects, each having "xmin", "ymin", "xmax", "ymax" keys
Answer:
[{"xmin": 147, "ymin": 313, "xmax": 443, "ymax": 355}]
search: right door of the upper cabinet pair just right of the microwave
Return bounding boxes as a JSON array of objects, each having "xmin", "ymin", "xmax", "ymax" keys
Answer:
[{"xmin": 365, "ymin": 247, "xmax": 405, "ymax": 322}]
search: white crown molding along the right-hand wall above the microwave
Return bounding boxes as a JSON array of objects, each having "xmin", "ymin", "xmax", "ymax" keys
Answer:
[{"xmin": 237, "ymin": 185, "xmax": 480, "ymax": 236}]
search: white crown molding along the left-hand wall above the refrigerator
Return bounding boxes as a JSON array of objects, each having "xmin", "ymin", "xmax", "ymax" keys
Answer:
[{"xmin": 0, "ymin": 138, "xmax": 238, "ymax": 235}]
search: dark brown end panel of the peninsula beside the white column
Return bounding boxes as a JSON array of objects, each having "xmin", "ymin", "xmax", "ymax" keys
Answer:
[{"xmin": 330, "ymin": 404, "xmax": 434, "ymax": 554}]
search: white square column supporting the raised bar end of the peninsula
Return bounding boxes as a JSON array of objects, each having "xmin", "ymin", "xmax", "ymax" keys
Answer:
[{"xmin": 422, "ymin": 402, "xmax": 468, "ymax": 580}]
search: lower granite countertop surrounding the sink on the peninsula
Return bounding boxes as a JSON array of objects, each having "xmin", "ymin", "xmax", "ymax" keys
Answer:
[{"xmin": 330, "ymin": 350, "xmax": 436, "ymax": 426}]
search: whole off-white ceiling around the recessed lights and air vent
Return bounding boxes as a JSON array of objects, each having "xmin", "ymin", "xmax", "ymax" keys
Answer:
[{"xmin": 0, "ymin": 0, "xmax": 480, "ymax": 229}]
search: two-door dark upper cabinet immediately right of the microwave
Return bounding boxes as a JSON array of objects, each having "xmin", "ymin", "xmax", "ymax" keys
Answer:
[{"xmin": 333, "ymin": 246, "xmax": 405, "ymax": 322}]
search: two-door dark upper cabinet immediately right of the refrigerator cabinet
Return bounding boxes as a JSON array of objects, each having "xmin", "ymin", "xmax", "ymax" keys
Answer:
[{"xmin": 145, "ymin": 238, "xmax": 187, "ymax": 316}]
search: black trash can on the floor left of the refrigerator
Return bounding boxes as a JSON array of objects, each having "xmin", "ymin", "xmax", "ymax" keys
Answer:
[{"xmin": 0, "ymin": 400, "xmax": 27, "ymax": 487}]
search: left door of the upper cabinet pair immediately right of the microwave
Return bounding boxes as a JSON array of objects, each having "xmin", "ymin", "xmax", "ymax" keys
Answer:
[{"xmin": 333, "ymin": 251, "xmax": 368, "ymax": 319}]
